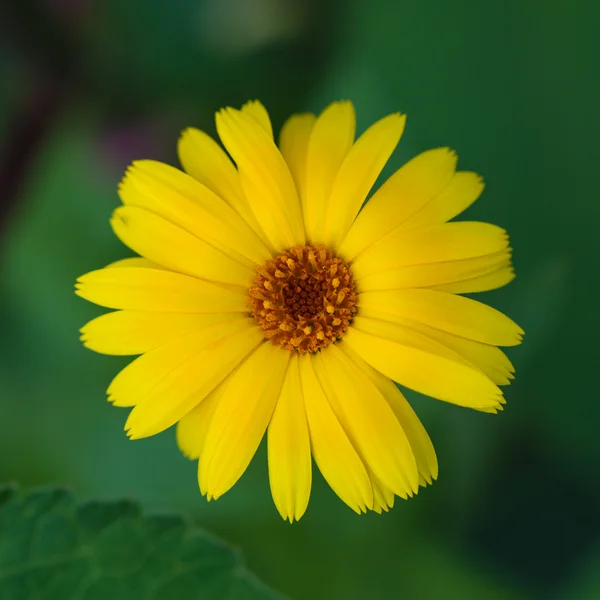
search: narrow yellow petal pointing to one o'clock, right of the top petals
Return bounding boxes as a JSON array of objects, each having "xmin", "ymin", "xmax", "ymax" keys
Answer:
[{"xmin": 324, "ymin": 113, "xmax": 406, "ymax": 248}]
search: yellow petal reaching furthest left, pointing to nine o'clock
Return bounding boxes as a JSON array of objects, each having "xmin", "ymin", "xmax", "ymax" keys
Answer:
[{"xmin": 75, "ymin": 263, "xmax": 248, "ymax": 313}]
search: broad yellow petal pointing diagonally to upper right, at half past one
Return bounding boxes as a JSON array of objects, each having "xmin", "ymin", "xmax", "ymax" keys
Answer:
[{"xmin": 339, "ymin": 148, "xmax": 457, "ymax": 260}]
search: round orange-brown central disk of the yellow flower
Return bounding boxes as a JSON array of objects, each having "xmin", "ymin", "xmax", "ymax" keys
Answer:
[{"xmin": 250, "ymin": 246, "xmax": 356, "ymax": 354}]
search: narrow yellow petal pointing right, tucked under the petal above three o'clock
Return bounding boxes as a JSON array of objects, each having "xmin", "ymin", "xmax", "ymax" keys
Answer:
[{"xmin": 360, "ymin": 250, "xmax": 511, "ymax": 293}]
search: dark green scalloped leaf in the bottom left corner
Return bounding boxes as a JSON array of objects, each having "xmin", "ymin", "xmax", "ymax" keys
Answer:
[{"xmin": 0, "ymin": 487, "xmax": 283, "ymax": 600}]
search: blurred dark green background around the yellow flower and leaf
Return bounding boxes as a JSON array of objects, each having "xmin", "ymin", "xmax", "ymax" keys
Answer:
[{"xmin": 0, "ymin": 0, "xmax": 600, "ymax": 600}]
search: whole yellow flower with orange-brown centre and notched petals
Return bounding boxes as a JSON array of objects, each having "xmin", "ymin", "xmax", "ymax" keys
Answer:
[{"xmin": 77, "ymin": 102, "xmax": 523, "ymax": 521}]
